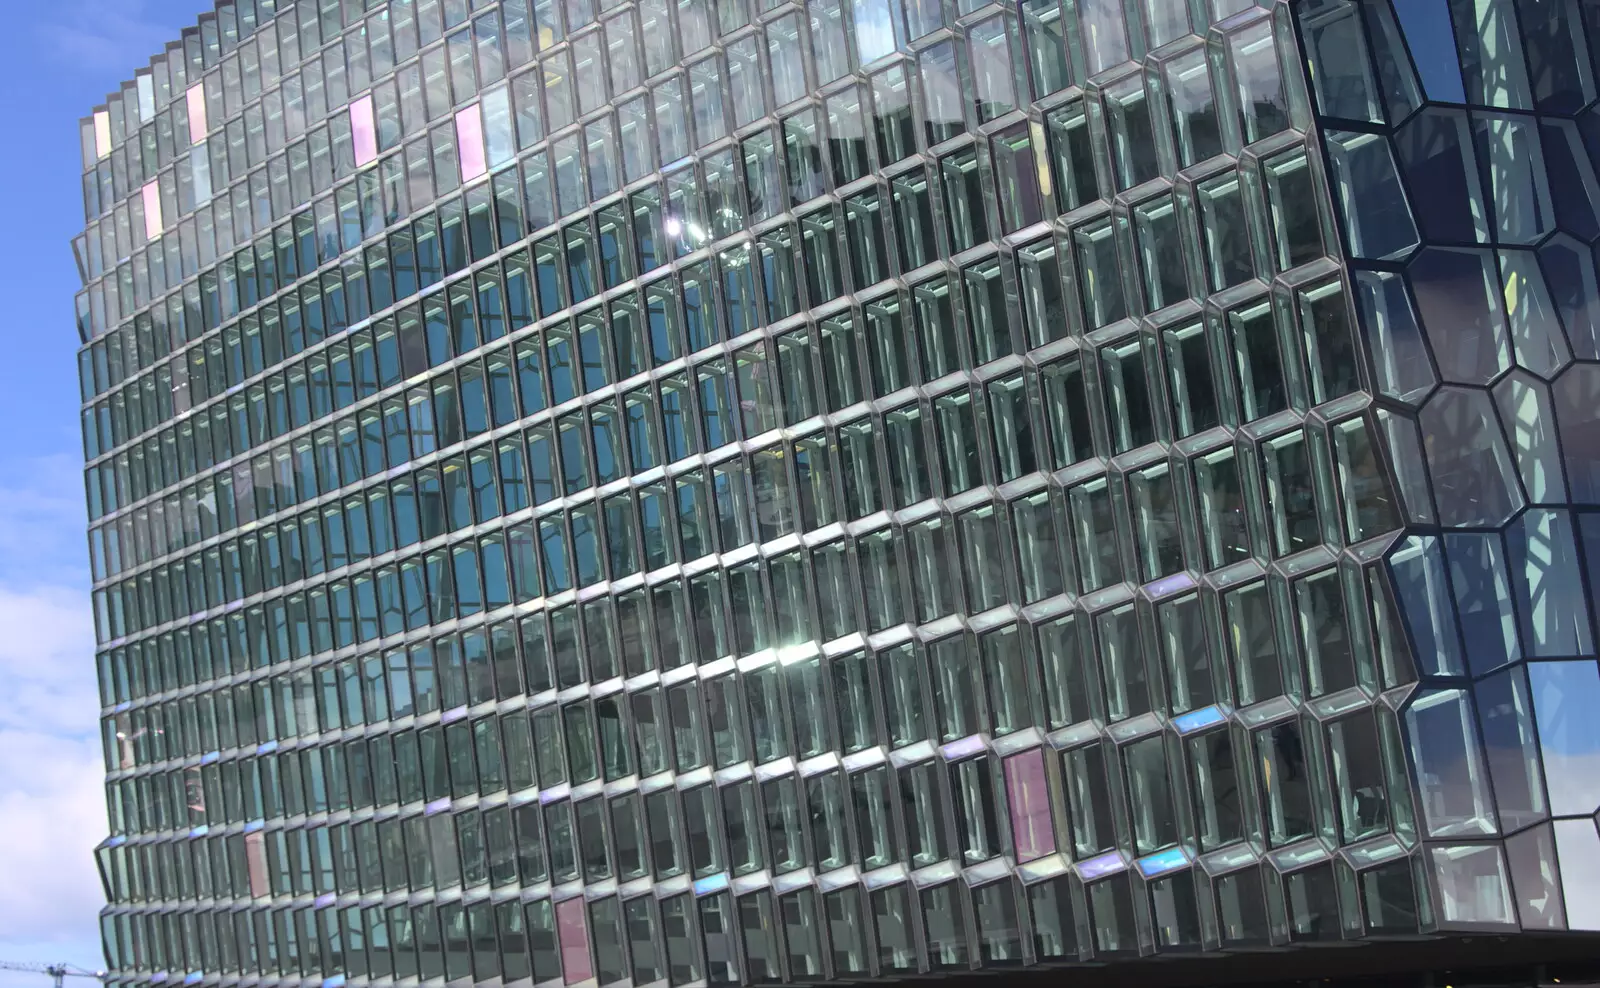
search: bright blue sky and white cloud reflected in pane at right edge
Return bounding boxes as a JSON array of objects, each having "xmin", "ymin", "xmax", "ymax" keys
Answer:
[{"xmin": 1528, "ymin": 659, "xmax": 1600, "ymax": 817}]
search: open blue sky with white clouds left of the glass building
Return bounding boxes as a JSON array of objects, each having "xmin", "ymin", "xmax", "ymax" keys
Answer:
[{"xmin": 0, "ymin": 0, "xmax": 211, "ymax": 988}]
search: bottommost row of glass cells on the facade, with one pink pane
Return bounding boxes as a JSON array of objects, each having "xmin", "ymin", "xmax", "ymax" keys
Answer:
[{"xmin": 104, "ymin": 860, "xmax": 1426, "ymax": 985}]
